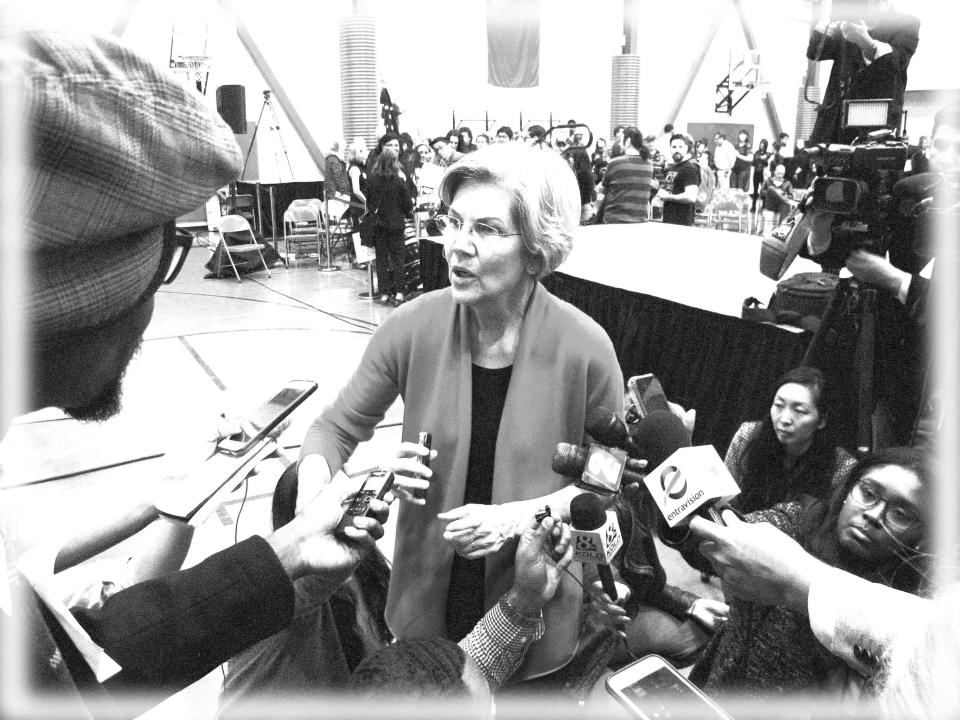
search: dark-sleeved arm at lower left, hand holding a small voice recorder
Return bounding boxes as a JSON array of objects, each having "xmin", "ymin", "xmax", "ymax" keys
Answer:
[{"xmin": 73, "ymin": 480, "xmax": 388, "ymax": 694}]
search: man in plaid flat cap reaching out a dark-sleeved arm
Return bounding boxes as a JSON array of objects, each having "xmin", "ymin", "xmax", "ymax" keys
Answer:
[{"xmin": 0, "ymin": 25, "xmax": 387, "ymax": 715}]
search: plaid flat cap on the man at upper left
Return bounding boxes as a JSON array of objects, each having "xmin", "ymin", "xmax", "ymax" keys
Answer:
[{"xmin": 18, "ymin": 30, "xmax": 241, "ymax": 341}]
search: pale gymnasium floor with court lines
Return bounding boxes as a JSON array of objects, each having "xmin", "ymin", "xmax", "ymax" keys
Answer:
[{"xmin": 0, "ymin": 233, "xmax": 719, "ymax": 719}]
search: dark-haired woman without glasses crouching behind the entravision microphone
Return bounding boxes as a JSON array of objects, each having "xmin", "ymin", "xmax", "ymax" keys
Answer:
[{"xmin": 724, "ymin": 366, "xmax": 854, "ymax": 512}]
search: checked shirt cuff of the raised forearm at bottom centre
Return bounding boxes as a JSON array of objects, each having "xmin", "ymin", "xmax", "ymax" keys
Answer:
[{"xmin": 459, "ymin": 598, "xmax": 545, "ymax": 688}]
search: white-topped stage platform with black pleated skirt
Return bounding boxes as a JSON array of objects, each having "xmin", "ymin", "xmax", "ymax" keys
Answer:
[{"xmin": 420, "ymin": 222, "xmax": 819, "ymax": 455}]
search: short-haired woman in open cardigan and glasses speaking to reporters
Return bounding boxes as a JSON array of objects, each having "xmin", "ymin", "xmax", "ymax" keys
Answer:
[{"xmin": 299, "ymin": 143, "xmax": 623, "ymax": 677}]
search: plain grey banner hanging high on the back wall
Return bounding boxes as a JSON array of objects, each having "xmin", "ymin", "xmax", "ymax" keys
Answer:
[{"xmin": 487, "ymin": 0, "xmax": 540, "ymax": 88}]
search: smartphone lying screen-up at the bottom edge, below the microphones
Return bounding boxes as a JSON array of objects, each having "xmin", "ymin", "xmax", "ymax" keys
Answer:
[{"xmin": 606, "ymin": 655, "xmax": 733, "ymax": 720}]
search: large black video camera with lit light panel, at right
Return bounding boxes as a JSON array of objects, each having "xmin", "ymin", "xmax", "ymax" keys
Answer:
[{"xmin": 760, "ymin": 129, "xmax": 909, "ymax": 280}]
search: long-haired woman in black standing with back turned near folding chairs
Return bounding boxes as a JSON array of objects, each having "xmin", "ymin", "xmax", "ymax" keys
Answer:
[{"xmin": 367, "ymin": 141, "xmax": 413, "ymax": 305}]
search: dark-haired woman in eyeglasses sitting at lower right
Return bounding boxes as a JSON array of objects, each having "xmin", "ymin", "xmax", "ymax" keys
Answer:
[{"xmin": 682, "ymin": 447, "xmax": 932, "ymax": 695}]
